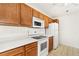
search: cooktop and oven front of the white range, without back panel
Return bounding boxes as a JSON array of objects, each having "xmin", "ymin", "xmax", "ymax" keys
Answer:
[{"xmin": 32, "ymin": 36, "xmax": 48, "ymax": 56}]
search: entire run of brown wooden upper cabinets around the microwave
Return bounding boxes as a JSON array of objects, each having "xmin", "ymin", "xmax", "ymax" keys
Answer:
[{"xmin": 0, "ymin": 3, "xmax": 59, "ymax": 28}]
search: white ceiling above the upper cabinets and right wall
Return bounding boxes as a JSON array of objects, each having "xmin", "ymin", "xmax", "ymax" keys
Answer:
[{"xmin": 29, "ymin": 3, "xmax": 79, "ymax": 18}]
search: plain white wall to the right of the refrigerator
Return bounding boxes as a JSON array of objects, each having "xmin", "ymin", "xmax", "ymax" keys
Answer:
[{"xmin": 59, "ymin": 13, "xmax": 79, "ymax": 48}]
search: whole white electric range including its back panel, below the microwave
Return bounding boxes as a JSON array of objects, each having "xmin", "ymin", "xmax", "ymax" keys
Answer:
[{"xmin": 29, "ymin": 28, "xmax": 48, "ymax": 56}]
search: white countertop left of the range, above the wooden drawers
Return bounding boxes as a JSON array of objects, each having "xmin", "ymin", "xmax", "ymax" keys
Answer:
[{"xmin": 0, "ymin": 37, "xmax": 37, "ymax": 53}]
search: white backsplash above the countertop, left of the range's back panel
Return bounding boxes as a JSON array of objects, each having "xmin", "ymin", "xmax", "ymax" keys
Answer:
[{"xmin": 0, "ymin": 26, "xmax": 28, "ymax": 42}]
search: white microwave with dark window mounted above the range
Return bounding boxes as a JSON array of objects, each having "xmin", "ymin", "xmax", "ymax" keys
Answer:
[{"xmin": 32, "ymin": 17, "xmax": 44, "ymax": 28}]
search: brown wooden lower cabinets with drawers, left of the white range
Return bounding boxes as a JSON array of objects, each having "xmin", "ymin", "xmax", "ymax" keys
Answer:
[{"xmin": 0, "ymin": 42, "xmax": 37, "ymax": 56}]
